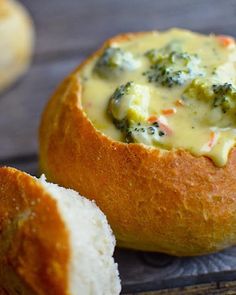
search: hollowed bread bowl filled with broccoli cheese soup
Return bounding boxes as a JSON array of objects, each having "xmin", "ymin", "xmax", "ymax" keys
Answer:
[{"xmin": 39, "ymin": 29, "xmax": 236, "ymax": 256}]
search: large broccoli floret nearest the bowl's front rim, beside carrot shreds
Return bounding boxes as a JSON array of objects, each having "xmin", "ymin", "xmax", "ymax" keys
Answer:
[{"xmin": 108, "ymin": 82, "xmax": 165, "ymax": 145}]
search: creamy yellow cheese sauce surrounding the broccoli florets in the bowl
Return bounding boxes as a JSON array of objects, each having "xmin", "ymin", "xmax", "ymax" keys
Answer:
[{"xmin": 80, "ymin": 29, "xmax": 236, "ymax": 166}]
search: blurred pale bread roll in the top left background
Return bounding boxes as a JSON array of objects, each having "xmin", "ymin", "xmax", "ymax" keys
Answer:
[{"xmin": 0, "ymin": 0, "xmax": 34, "ymax": 92}]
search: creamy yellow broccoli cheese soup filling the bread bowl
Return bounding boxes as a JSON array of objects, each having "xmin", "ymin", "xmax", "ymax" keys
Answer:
[{"xmin": 80, "ymin": 29, "xmax": 236, "ymax": 166}]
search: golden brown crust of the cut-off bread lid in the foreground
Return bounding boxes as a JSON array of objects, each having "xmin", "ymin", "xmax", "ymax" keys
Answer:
[{"xmin": 0, "ymin": 168, "xmax": 70, "ymax": 295}]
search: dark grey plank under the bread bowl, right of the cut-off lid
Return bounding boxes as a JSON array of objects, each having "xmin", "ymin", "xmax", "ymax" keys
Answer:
[{"xmin": 115, "ymin": 248, "xmax": 236, "ymax": 294}]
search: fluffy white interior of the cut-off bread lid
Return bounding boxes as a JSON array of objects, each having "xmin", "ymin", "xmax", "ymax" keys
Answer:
[{"xmin": 39, "ymin": 176, "xmax": 121, "ymax": 295}]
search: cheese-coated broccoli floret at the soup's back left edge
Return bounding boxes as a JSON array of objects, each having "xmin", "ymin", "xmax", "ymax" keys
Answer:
[{"xmin": 94, "ymin": 47, "xmax": 139, "ymax": 78}]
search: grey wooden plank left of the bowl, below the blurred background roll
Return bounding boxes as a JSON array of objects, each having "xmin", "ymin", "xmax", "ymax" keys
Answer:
[{"xmin": 0, "ymin": 57, "xmax": 81, "ymax": 162}]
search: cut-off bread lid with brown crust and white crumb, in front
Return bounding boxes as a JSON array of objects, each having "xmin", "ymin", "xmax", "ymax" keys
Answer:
[{"xmin": 0, "ymin": 167, "xmax": 120, "ymax": 295}]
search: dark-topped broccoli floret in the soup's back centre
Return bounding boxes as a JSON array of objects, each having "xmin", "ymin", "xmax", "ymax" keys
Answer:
[{"xmin": 143, "ymin": 49, "xmax": 203, "ymax": 87}]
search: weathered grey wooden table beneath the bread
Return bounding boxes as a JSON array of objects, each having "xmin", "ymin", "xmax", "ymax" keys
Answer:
[{"xmin": 0, "ymin": 0, "xmax": 236, "ymax": 295}]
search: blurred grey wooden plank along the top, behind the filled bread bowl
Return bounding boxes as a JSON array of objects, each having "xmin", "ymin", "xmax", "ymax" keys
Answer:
[{"xmin": 22, "ymin": 0, "xmax": 236, "ymax": 58}]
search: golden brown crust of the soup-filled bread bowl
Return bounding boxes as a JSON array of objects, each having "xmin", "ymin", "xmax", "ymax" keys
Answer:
[{"xmin": 40, "ymin": 34, "xmax": 236, "ymax": 256}]
